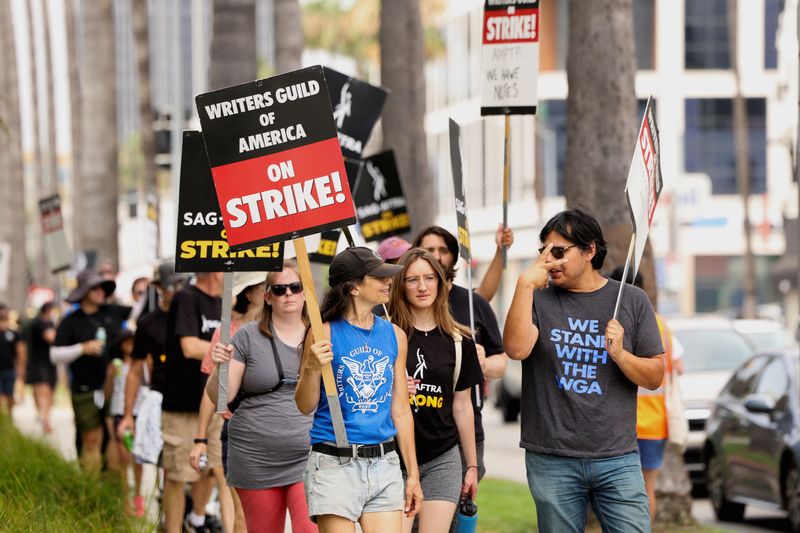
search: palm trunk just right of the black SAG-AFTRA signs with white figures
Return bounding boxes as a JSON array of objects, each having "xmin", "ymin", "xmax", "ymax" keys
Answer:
[{"xmin": 379, "ymin": 0, "xmax": 438, "ymax": 232}]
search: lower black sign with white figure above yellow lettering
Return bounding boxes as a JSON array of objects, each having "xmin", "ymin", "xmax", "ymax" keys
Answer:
[{"xmin": 353, "ymin": 150, "xmax": 411, "ymax": 242}]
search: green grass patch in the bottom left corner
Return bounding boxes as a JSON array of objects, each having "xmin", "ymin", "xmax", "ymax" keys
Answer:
[{"xmin": 0, "ymin": 416, "xmax": 144, "ymax": 533}]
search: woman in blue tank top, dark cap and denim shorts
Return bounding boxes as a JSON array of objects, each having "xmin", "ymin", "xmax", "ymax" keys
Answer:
[{"xmin": 295, "ymin": 247, "xmax": 422, "ymax": 533}]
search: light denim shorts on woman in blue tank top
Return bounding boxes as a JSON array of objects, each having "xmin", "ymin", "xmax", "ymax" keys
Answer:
[{"xmin": 303, "ymin": 444, "xmax": 405, "ymax": 522}]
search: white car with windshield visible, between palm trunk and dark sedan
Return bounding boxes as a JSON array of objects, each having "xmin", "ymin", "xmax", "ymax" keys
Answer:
[{"xmin": 668, "ymin": 316, "xmax": 754, "ymax": 486}]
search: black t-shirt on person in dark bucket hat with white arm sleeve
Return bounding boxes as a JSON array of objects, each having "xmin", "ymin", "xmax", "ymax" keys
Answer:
[{"xmin": 55, "ymin": 304, "xmax": 131, "ymax": 392}]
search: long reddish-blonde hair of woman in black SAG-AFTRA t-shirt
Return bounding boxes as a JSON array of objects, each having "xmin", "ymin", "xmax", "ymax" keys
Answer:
[{"xmin": 389, "ymin": 248, "xmax": 472, "ymax": 337}]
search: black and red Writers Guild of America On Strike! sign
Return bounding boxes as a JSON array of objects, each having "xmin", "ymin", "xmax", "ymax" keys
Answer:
[{"xmin": 195, "ymin": 66, "xmax": 355, "ymax": 250}]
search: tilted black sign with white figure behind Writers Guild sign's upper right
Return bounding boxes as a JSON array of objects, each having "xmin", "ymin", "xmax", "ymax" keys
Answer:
[{"xmin": 323, "ymin": 67, "xmax": 389, "ymax": 159}]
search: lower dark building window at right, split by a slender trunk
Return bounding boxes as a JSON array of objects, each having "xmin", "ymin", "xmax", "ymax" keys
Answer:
[{"xmin": 684, "ymin": 98, "xmax": 767, "ymax": 194}]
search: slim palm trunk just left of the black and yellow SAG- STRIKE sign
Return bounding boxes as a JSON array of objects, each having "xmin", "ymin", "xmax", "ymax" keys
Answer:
[{"xmin": 133, "ymin": 0, "xmax": 161, "ymax": 257}]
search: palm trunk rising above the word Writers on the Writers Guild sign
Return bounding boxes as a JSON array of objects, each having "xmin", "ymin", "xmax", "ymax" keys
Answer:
[{"xmin": 208, "ymin": 0, "xmax": 257, "ymax": 90}]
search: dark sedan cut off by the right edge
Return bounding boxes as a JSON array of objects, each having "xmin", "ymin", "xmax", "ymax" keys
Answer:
[{"xmin": 704, "ymin": 347, "xmax": 800, "ymax": 533}]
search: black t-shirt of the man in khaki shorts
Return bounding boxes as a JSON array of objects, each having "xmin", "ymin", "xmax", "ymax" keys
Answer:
[{"xmin": 162, "ymin": 285, "xmax": 222, "ymax": 413}]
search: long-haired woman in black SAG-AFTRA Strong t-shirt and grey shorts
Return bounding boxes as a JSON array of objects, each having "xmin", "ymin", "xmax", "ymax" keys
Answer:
[{"xmin": 389, "ymin": 248, "xmax": 483, "ymax": 533}]
